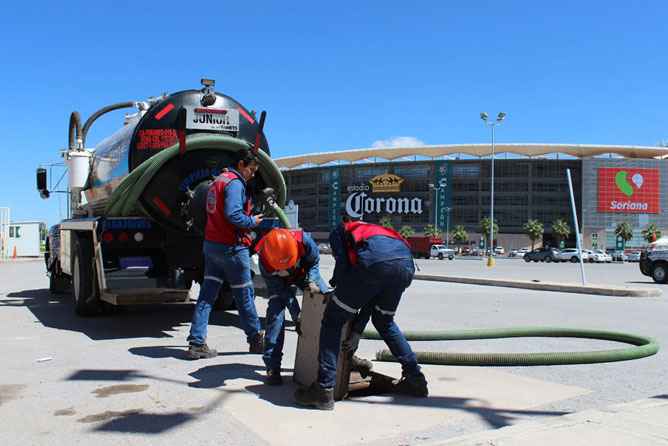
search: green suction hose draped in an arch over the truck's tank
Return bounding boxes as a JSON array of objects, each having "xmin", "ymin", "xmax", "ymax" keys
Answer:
[{"xmin": 104, "ymin": 135, "xmax": 287, "ymax": 218}]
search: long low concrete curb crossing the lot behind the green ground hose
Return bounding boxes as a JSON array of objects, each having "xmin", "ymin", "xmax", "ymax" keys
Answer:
[{"xmin": 414, "ymin": 274, "xmax": 662, "ymax": 297}]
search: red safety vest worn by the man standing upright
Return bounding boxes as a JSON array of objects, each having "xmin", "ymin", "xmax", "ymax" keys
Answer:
[{"xmin": 204, "ymin": 170, "xmax": 252, "ymax": 246}]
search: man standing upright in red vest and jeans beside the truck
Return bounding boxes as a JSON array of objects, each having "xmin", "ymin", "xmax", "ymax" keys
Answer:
[{"xmin": 187, "ymin": 149, "xmax": 264, "ymax": 359}]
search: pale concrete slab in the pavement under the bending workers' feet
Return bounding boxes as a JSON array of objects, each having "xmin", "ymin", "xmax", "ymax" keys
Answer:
[{"xmin": 217, "ymin": 362, "xmax": 588, "ymax": 446}]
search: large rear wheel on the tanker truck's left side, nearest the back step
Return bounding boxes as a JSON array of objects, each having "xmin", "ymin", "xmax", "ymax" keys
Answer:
[{"xmin": 72, "ymin": 234, "xmax": 100, "ymax": 317}]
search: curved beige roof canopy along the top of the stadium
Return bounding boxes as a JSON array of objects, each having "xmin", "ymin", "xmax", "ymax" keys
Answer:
[{"xmin": 274, "ymin": 143, "xmax": 668, "ymax": 169}]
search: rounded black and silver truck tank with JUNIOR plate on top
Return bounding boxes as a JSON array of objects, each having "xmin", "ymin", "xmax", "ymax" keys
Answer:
[{"xmin": 84, "ymin": 85, "xmax": 285, "ymax": 235}]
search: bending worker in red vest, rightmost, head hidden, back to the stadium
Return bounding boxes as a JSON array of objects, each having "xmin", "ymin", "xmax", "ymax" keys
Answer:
[{"xmin": 295, "ymin": 222, "xmax": 428, "ymax": 410}]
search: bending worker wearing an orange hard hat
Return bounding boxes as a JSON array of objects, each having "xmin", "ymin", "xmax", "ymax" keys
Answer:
[{"xmin": 255, "ymin": 229, "xmax": 329, "ymax": 386}]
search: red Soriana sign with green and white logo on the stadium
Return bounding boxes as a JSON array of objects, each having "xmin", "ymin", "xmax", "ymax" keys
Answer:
[{"xmin": 598, "ymin": 167, "xmax": 659, "ymax": 214}]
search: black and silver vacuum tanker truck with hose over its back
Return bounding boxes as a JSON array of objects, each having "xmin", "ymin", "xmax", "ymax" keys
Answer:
[{"xmin": 37, "ymin": 79, "xmax": 289, "ymax": 316}]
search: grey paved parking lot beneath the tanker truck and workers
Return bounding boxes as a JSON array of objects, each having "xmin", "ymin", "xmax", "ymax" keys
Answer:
[{"xmin": 0, "ymin": 256, "xmax": 668, "ymax": 446}]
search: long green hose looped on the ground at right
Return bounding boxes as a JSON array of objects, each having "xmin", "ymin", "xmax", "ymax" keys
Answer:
[{"xmin": 363, "ymin": 327, "xmax": 659, "ymax": 366}]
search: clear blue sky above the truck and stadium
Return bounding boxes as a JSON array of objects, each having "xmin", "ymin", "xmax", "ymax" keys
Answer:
[{"xmin": 0, "ymin": 0, "xmax": 668, "ymax": 225}]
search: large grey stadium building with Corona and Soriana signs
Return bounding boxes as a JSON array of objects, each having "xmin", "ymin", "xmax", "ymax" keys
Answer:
[{"xmin": 276, "ymin": 144, "xmax": 668, "ymax": 250}]
